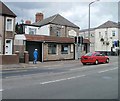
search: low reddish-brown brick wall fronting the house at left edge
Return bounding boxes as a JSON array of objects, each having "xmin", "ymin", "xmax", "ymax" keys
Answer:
[{"xmin": 0, "ymin": 54, "xmax": 19, "ymax": 65}]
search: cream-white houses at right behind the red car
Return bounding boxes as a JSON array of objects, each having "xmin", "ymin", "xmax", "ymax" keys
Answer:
[{"xmin": 79, "ymin": 21, "xmax": 120, "ymax": 55}]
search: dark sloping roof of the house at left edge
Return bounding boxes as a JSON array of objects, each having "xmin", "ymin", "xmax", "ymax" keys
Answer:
[{"xmin": 0, "ymin": 1, "xmax": 16, "ymax": 17}]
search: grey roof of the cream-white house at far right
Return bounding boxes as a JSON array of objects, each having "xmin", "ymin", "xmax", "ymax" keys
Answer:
[{"xmin": 97, "ymin": 21, "xmax": 118, "ymax": 28}]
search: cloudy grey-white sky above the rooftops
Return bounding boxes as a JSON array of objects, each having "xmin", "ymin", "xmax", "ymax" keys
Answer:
[{"xmin": 2, "ymin": 0, "xmax": 119, "ymax": 29}]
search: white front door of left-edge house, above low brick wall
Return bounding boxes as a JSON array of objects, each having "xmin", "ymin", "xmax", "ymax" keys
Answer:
[{"xmin": 5, "ymin": 39, "xmax": 12, "ymax": 55}]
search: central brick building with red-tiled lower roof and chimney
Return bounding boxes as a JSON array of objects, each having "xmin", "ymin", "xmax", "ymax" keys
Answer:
[{"xmin": 15, "ymin": 13, "xmax": 79, "ymax": 62}]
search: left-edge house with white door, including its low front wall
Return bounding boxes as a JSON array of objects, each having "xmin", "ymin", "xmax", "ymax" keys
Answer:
[{"xmin": 0, "ymin": 2, "xmax": 18, "ymax": 64}]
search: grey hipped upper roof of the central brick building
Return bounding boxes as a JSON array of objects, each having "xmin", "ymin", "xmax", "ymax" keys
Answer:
[{"xmin": 33, "ymin": 14, "xmax": 79, "ymax": 28}]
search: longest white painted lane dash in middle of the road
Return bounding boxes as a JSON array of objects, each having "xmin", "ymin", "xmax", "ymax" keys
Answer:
[{"xmin": 40, "ymin": 75, "xmax": 86, "ymax": 85}]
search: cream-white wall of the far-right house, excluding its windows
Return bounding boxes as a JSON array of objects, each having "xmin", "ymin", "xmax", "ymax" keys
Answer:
[{"xmin": 95, "ymin": 28, "xmax": 118, "ymax": 51}]
